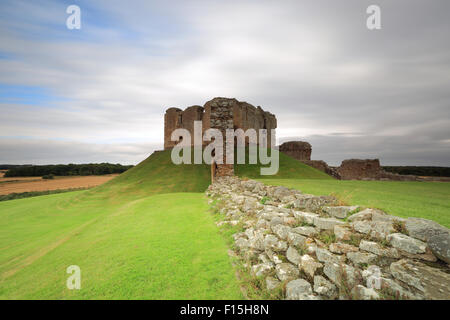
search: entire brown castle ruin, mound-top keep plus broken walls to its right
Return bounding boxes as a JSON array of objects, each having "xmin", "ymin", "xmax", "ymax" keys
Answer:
[{"xmin": 164, "ymin": 97, "xmax": 422, "ymax": 181}]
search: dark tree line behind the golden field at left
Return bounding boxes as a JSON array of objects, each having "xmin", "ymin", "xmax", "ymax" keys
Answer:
[{"xmin": 5, "ymin": 163, "xmax": 133, "ymax": 177}]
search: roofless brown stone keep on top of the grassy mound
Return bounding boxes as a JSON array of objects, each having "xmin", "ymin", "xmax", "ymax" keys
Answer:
[{"xmin": 164, "ymin": 97, "xmax": 277, "ymax": 149}]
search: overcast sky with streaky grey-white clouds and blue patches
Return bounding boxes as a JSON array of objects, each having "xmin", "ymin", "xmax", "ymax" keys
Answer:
[{"xmin": 0, "ymin": 0, "xmax": 450, "ymax": 166}]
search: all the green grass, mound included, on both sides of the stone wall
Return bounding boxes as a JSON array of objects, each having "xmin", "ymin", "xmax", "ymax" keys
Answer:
[{"xmin": 0, "ymin": 151, "xmax": 450, "ymax": 299}]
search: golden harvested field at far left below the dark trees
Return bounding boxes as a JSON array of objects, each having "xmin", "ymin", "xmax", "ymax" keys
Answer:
[{"xmin": 0, "ymin": 174, "xmax": 118, "ymax": 195}]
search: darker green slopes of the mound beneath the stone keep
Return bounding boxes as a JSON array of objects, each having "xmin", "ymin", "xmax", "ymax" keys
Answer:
[{"xmin": 88, "ymin": 150, "xmax": 333, "ymax": 199}]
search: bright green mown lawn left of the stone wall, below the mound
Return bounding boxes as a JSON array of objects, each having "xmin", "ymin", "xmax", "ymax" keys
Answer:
[{"xmin": 0, "ymin": 191, "xmax": 242, "ymax": 299}]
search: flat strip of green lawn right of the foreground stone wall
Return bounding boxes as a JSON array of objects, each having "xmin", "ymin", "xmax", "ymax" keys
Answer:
[{"xmin": 258, "ymin": 179, "xmax": 450, "ymax": 228}]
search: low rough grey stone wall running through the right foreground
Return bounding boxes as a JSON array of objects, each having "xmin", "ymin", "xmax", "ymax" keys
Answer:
[{"xmin": 206, "ymin": 177, "xmax": 450, "ymax": 300}]
